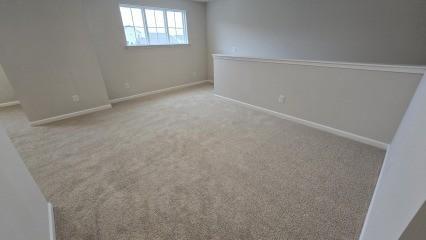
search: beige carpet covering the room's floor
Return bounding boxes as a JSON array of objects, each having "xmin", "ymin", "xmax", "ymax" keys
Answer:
[{"xmin": 0, "ymin": 85, "xmax": 384, "ymax": 240}]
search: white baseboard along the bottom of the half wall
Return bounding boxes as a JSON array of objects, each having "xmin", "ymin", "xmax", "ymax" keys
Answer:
[{"xmin": 215, "ymin": 94, "xmax": 388, "ymax": 149}]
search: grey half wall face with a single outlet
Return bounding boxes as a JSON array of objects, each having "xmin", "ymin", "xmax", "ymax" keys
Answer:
[{"xmin": 214, "ymin": 57, "xmax": 422, "ymax": 143}]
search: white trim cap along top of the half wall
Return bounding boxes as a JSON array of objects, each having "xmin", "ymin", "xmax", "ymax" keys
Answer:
[{"xmin": 213, "ymin": 54, "xmax": 426, "ymax": 74}]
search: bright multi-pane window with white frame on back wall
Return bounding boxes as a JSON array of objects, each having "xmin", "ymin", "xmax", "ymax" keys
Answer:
[{"xmin": 120, "ymin": 5, "xmax": 188, "ymax": 46}]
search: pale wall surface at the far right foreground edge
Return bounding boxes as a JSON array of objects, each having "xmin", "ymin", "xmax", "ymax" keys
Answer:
[{"xmin": 360, "ymin": 77, "xmax": 426, "ymax": 240}]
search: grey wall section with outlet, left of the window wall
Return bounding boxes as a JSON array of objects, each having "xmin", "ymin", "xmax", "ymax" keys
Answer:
[{"xmin": 0, "ymin": 0, "xmax": 109, "ymax": 121}]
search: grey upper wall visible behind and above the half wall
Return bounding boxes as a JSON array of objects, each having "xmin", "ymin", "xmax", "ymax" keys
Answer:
[{"xmin": 207, "ymin": 0, "xmax": 426, "ymax": 77}]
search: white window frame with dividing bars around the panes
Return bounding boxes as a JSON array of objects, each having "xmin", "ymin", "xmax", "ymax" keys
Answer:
[{"xmin": 118, "ymin": 3, "xmax": 190, "ymax": 48}]
